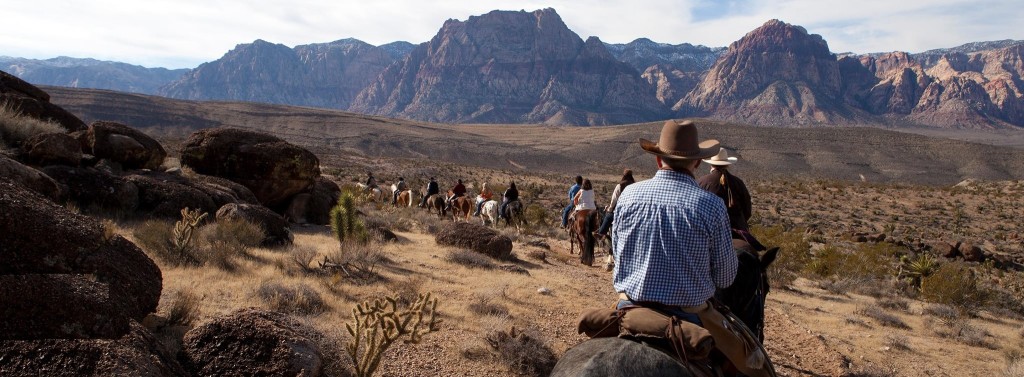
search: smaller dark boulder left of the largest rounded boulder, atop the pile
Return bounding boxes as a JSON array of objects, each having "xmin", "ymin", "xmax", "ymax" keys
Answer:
[{"xmin": 85, "ymin": 121, "xmax": 167, "ymax": 169}]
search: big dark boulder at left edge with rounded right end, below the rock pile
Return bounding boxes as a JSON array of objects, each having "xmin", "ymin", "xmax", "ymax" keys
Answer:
[{"xmin": 0, "ymin": 177, "xmax": 163, "ymax": 320}]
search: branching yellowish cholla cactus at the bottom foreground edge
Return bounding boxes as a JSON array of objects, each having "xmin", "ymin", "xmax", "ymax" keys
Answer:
[{"xmin": 345, "ymin": 293, "xmax": 439, "ymax": 377}]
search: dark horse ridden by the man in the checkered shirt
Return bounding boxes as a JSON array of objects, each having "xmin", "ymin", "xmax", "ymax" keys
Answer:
[{"xmin": 551, "ymin": 242, "xmax": 778, "ymax": 377}]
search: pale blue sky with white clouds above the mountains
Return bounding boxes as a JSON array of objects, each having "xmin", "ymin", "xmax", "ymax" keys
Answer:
[{"xmin": 0, "ymin": 0, "xmax": 1024, "ymax": 69}]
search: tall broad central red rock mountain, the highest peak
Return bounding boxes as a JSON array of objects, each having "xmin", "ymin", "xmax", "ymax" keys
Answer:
[{"xmin": 349, "ymin": 9, "xmax": 670, "ymax": 125}]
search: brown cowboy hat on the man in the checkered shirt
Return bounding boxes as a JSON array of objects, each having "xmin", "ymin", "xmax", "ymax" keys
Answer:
[{"xmin": 640, "ymin": 119, "xmax": 719, "ymax": 160}]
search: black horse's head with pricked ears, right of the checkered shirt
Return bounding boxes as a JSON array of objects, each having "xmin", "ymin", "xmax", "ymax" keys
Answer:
[{"xmin": 715, "ymin": 240, "xmax": 779, "ymax": 340}]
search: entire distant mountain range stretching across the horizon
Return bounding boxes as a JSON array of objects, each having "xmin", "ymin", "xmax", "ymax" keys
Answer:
[{"xmin": 0, "ymin": 8, "xmax": 1024, "ymax": 129}]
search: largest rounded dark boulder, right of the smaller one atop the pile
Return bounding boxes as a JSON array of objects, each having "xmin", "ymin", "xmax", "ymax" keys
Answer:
[{"xmin": 181, "ymin": 128, "xmax": 319, "ymax": 209}]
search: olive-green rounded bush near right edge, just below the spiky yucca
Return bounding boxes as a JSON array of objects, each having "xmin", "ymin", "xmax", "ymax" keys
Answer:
[{"xmin": 921, "ymin": 262, "xmax": 985, "ymax": 311}]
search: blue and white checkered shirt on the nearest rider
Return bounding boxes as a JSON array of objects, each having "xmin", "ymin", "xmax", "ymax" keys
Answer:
[{"xmin": 611, "ymin": 170, "xmax": 737, "ymax": 306}]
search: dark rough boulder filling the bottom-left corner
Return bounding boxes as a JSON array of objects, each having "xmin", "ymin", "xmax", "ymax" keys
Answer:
[{"xmin": 0, "ymin": 322, "xmax": 187, "ymax": 377}]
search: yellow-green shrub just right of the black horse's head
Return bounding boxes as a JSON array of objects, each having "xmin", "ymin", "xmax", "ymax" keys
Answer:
[{"xmin": 751, "ymin": 225, "xmax": 811, "ymax": 287}]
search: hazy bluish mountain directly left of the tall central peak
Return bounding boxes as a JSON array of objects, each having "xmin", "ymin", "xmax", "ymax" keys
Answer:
[{"xmin": 160, "ymin": 39, "xmax": 401, "ymax": 109}]
